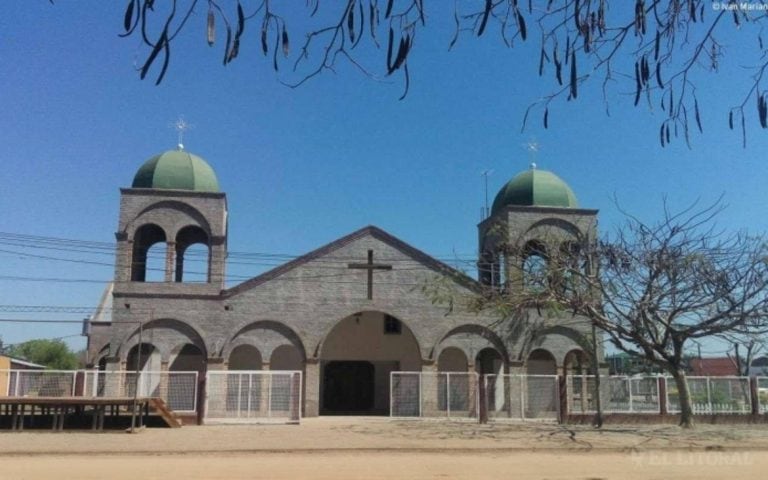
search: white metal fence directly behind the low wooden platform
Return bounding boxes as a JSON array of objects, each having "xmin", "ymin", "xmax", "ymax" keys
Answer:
[{"xmin": 0, "ymin": 370, "xmax": 198, "ymax": 413}]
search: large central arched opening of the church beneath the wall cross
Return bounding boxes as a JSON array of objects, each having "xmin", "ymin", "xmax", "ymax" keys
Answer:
[{"xmin": 320, "ymin": 311, "xmax": 421, "ymax": 415}]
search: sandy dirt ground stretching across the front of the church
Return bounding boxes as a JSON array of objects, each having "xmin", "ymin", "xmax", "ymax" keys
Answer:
[{"xmin": 0, "ymin": 417, "xmax": 768, "ymax": 480}]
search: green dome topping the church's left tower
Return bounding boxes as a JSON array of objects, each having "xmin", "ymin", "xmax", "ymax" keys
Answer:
[{"xmin": 133, "ymin": 150, "xmax": 219, "ymax": 192}]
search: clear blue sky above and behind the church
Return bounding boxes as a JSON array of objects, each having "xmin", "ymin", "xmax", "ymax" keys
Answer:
[{"xmin": 0, "ymin": 0, "xmax": 768, "ymax": 356}]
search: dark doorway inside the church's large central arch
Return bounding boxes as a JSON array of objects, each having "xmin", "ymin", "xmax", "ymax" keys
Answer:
[{"xmin": 321, "ymin": 361, "xmax": 375, "ymax": 415}]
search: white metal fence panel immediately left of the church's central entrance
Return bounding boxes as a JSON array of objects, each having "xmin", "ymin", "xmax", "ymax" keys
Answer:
[{"xmin": 205, "ymin": 370, "xmax": 302, "ymax": 423}]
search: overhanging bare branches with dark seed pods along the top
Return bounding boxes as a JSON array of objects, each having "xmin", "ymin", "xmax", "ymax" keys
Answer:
[{"xmin": 111, "ymin": 0, "xmax": 768, "ymax": 146}]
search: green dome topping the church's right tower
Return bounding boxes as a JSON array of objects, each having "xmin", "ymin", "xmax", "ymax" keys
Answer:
[{"xmin": 491, "ymin": 168, "xmax": 579, "ymax": 214}]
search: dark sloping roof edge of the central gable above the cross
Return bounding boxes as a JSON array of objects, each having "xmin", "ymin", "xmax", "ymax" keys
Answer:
[{"xmin": 222, "ymin": 225, "xmax": 480, "ymax": 298}]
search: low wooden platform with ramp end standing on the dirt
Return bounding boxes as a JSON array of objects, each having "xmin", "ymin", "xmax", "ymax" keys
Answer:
[{"xmin": 0, "ymin": 396, "xmax": 181, "ymax": 431}]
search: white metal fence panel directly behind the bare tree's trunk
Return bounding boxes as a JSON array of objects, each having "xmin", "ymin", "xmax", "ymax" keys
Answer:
[{"xmin": 665, "ymin": 377, "xmax": 752, "ymax": 414}]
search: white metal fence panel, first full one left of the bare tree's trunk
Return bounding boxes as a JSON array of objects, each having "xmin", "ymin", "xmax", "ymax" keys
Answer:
[{"xmin": 567, "ymin": 375, "xmax": 661, "ymax": 414}]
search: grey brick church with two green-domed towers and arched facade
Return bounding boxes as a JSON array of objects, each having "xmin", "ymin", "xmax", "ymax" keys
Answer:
[{"xmin": 88, "ymin": 148, "xmax": 602, "ymax": 416}]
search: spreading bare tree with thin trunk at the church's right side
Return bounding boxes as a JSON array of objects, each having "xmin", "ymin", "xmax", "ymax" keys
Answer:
[{"xmin": 462, "ymin": 202, "xmax": 768, "ymax": 427}]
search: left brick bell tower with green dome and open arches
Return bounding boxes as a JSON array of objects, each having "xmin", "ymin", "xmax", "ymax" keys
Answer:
[{"xmin": 114, "ymin": 148, "xmax": 227, "ymax": 295}]
